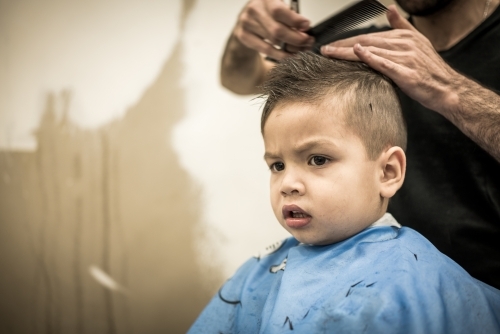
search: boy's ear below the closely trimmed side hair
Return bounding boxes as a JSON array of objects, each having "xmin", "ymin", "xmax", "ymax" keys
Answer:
[{"xmin": 380, "ymin": 146, "xmax": 406, "ymax": 198}]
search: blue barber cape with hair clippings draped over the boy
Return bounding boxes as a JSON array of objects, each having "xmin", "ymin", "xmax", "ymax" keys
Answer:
[{"xmin": 189, "ymin": 215, "xmax": 500, "ymax": 334}]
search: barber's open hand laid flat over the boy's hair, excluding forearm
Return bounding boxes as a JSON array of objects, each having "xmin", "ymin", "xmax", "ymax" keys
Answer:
[{"xmin": 321, "ymin": 6, "xmax": 463, "ymax": 114}]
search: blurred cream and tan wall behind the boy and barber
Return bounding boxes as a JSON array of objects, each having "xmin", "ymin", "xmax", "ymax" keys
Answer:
[{"xmin": 0, "ymin": 0, "xmax": 391, "ymax": 334}]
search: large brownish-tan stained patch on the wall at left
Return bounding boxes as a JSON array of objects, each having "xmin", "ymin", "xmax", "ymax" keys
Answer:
[{"xmin": 0, "ymin": 0, "xmax": 220, "ymax": 334}]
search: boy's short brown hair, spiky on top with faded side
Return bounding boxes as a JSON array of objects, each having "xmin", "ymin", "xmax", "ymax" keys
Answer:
[{"xmin": 261, "ymin": 52, "xmax": 406, "ymax": 160}]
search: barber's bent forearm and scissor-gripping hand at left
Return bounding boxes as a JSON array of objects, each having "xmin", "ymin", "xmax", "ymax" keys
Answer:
[{"xmin": 220, "ymin": 0, "xmax": 314, "ymax": 94}]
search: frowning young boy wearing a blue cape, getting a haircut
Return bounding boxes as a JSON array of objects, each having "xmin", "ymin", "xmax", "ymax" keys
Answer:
[{"xmin": 190, "ymin": 53, "xmax": 500, "ymax": 333}]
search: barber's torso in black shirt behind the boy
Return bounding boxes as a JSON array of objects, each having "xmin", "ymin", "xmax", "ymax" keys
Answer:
[{"xmin": 389, "ymin": 9, "xmax": 500, "ymax": 288}]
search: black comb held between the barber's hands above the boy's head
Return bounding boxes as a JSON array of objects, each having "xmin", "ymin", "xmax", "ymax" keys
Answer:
[{"xmin": 307, "ymin": 0, "xmax": 387, "ymax": 53}]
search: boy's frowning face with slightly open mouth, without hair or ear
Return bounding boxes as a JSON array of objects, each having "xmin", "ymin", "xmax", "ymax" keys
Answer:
[{"xmin": 264, "ymin": 102, "xmax": 385, "ymax": 245}]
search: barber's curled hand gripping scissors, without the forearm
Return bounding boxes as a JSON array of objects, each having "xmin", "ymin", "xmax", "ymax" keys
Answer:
[{"xmin": 233, "ymin": 0, "xmax": 314, "ymax": 60}]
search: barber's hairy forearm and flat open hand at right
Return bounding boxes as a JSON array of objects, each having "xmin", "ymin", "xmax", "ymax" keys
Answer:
[{"xmin": 322, "ymin": 7, "xmax": 500, "ymax": 162}]
